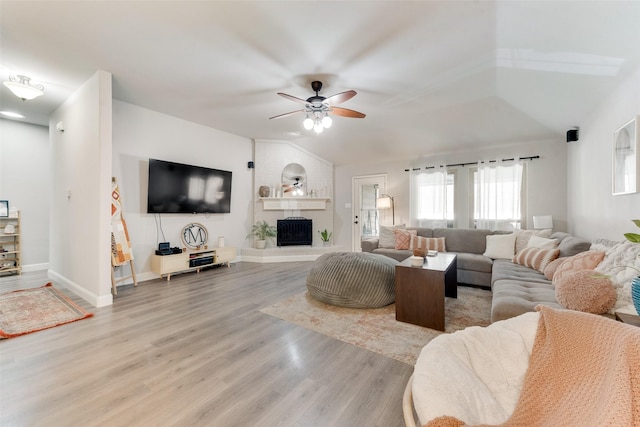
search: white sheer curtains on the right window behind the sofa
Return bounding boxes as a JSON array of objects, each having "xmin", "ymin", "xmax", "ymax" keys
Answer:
[{"xmin": 474, "ymin": 162, "xmax": 523, "ymax": 230}]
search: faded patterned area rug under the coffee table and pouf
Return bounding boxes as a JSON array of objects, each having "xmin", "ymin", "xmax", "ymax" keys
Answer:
[{"xmin": 260, "ymin": 286, "xmax": 491, "ymax": 365}]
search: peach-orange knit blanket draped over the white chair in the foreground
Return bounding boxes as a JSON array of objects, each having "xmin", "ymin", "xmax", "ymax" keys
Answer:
[{"xmin": 426, "ymin": 306, "xmax": 640, "ymax": 427}]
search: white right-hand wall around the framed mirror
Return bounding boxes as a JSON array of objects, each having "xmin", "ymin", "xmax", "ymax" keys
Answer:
[{"xmin": 567, "ymin": 68, "xmax": 640, "ymax": 240}]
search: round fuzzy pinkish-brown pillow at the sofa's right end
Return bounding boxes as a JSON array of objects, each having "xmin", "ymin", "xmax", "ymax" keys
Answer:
[{"xmin": 556, "ymin": 270, "xmax": 616, "ymax": 314}]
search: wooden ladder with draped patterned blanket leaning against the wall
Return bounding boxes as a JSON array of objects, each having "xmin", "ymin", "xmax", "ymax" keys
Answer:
[{"xmin": 111, "ymin": 177, "xmax": 138, "ymax": 295}]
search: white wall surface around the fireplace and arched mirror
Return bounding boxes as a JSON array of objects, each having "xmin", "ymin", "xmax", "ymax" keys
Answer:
[{"xmin": 252, "ymin": 140, "xmax": 334, "ymax": 246}]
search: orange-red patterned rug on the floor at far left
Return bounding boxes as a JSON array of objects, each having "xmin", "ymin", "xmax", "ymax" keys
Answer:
[{"xmin": 0, "ymin": 283, "xmax": 93, "ymax": 339}]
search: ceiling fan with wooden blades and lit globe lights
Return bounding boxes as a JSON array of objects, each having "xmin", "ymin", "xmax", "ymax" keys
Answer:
[{"xmin": 270, "ymin": 80, "xmax": 365, "ymax": 133}]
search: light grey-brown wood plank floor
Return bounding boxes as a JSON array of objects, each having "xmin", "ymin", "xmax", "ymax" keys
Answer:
[{"xmin": 0, "ymin": 262, "xmax": 413, "ymax": 427}]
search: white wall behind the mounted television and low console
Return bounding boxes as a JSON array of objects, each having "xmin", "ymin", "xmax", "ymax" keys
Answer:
[{"xmin": 113, "ymin": 100, "xmax": 253, "ymax": 283}]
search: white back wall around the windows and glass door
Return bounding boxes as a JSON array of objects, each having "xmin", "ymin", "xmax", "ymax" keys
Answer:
[{"xmin": 334, "ymin": 140, "xmax": 567, "ymax": 251}]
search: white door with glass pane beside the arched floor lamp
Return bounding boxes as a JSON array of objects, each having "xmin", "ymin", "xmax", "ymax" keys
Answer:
[{"xmin": 351, "ymin": 174, "xmax": 387, "ymax": 252}]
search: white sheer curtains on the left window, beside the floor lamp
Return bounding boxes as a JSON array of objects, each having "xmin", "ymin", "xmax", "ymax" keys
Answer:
[{"xmin": 410, "ymin": 168, "xmax": 453, "ymax": 228}]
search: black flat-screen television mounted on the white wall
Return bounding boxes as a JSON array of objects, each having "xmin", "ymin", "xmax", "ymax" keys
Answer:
[{"xmin": 147, "ymin": 159, "xmax": 231, "ymax": 213}]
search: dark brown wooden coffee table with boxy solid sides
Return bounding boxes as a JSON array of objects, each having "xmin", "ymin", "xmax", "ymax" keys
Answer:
[{"xmin": 396, "ymin": 252, "xmax": 458, "ymax": 331}]
